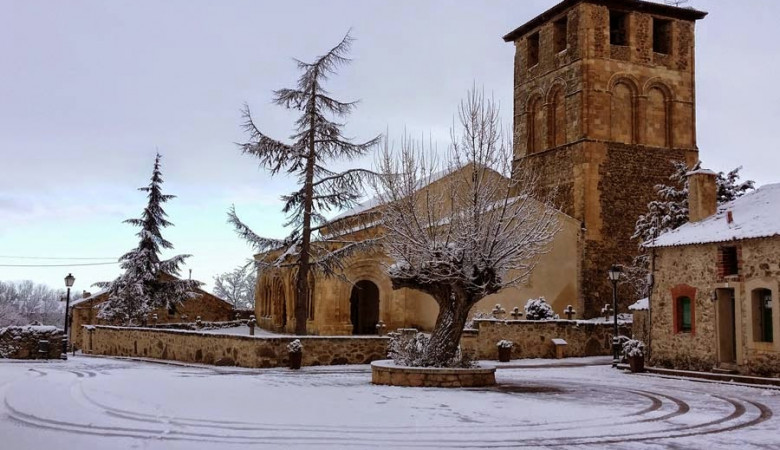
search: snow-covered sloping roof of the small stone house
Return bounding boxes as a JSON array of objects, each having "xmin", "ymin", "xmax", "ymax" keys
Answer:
[{"xmin": 645, "ymin": 183, "xmax": 780, "ymax": 247}]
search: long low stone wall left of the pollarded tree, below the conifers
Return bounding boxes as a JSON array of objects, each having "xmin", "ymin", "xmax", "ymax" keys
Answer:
[{"xmin": 82, "ymin": 326, "xmax": 388, "ymax": 367}]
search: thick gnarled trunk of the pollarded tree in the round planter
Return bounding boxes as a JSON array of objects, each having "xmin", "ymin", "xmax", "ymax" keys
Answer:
[{"xmin": 425, "ymin": 295, "xmax": 471, "ymax": 366}]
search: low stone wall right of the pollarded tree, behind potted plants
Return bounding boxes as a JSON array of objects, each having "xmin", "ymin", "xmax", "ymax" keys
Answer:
[{"xmin": 460, "ymin": 319, "xmax": 631, "ymax": 359}]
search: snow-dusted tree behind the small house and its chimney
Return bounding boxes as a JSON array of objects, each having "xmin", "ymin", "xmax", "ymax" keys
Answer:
[{"xmin": 626, "ymin": 161, "xmax": 755, "ymax": 298}]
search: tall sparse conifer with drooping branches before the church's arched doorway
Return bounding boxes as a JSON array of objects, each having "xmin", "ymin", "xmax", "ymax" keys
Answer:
[{"xmin": 228, "ymin": 33, "xmax": 379, "ymax": 334}]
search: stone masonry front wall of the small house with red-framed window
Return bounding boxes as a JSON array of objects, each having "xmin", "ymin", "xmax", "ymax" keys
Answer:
[{"xmin": 650, "ymin": 237, "xmax": 780, "ymax": 376}]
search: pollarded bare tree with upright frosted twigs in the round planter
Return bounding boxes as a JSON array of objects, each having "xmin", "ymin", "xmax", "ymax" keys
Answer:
[{"xmin": 377, "ymin": 89, "xmax": 559, "ymax": 366}]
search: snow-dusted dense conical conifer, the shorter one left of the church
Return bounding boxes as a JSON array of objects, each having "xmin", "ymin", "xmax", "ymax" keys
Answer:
[{"xmin": 95, "ymin": 153, "xmax": 201, "ymax": 325}]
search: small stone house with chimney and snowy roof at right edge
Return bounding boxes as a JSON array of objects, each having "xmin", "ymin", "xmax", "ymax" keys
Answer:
[{"xmin": 648, "ymin": 171, "xmax": 780, "ymax": 376}]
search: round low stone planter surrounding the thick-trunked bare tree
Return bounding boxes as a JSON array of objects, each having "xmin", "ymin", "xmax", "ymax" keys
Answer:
[{"xmin": 371, "ymin": 359, "xmax": 496, "ymax": 387}]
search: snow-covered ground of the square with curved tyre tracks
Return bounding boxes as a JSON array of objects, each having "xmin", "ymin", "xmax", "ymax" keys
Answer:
[{"xmin": 0, "ymin": 357, "xmax": 780, "ymax": 450}]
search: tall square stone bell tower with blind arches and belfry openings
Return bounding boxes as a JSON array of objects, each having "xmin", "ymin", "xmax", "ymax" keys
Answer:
[{"xmin": 504, "ymin": 0, "xmax": 707, "ymax": 317}]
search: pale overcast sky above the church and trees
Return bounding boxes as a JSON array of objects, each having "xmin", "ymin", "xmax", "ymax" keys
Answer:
[{"xmin": 0, "ymin": 0, "xmax": 780, "ymax": 291}]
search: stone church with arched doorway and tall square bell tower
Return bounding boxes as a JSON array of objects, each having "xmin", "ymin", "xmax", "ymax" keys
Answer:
[{"xmin": 256, "ymin": 0, "xmax": 706, "ymax": 335}]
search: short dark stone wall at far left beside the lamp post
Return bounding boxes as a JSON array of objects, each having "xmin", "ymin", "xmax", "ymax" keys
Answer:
[{"xmin": 0, "ymin": 325, "xmax": 64, "ymax": 359}]
